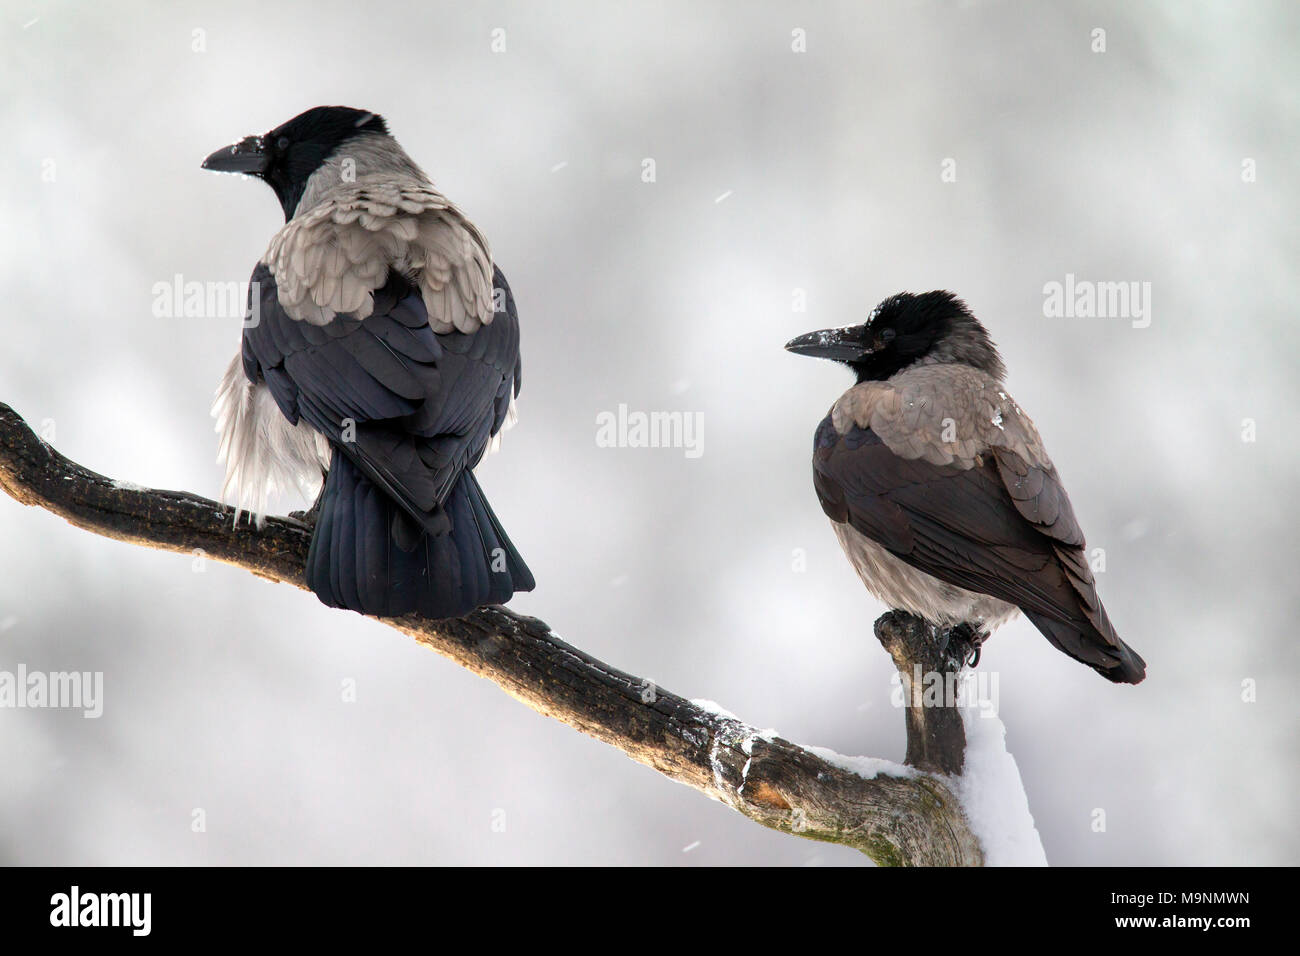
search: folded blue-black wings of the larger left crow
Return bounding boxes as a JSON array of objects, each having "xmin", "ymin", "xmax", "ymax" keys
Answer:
[{"xmin": 243, "ymin": 264, "xmax": 520, "ymax": 531}]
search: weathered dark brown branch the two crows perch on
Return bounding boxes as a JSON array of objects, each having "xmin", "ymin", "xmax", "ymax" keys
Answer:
[{"xmin": 0, "ymin": 403, "xmax": 983, "ymax": 866}]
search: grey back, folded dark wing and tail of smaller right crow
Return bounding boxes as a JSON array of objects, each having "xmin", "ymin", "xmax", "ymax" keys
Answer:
[{"xmin": 814, "ymin": 367, "xmax": 1143, "ymax": 680}]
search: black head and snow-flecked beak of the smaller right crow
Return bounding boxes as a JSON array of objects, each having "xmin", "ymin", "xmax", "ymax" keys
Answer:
[{"xmin": 785, "ymin": 291, "xmax": 1006, "ymax": 382}]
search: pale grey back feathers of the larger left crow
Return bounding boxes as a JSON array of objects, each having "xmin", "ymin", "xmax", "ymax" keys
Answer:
[{"xmin": 263, "ymin": 177, "xmax": 493, "ymax": 334}]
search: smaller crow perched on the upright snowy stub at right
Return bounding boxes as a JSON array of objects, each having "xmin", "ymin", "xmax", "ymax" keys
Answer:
[{"xmin": 785, "ymin": 291, "xmax": 1147, "ymax": 684}]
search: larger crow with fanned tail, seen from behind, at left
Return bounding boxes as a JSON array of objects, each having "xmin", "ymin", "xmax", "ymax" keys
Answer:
[{"xmin": 203, "ymin": 107, "xmax": 533, "ymax": 618}]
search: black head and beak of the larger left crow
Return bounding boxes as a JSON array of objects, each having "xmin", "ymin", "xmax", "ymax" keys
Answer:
[{"xmin": 203, "ymin": 107, "xmax": 389, "ymax": 220}]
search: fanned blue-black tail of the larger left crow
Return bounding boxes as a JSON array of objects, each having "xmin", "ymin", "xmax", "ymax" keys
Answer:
[{"xmin": 307, "ymin": 451, "xmax": 534, "ymax": 618}]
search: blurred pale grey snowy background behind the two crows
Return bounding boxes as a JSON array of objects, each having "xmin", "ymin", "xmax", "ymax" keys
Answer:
[{"xmin": 0, "ymin": 0, "xmax": 1300, "ymax": 865}]
